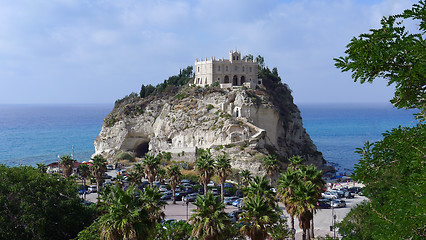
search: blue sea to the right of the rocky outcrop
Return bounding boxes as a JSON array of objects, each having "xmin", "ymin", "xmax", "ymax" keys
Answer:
[{"xmin": 299, "ymin": 104, "xmax": 417, "ymax": 173}]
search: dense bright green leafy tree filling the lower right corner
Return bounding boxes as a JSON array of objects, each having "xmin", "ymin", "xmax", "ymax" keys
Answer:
[{"xmin": 340, "ymin": 124, "xmax": 426, "ymax": 239}]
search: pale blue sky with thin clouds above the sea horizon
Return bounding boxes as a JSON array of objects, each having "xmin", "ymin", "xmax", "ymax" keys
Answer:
[{"xmin": 0, "ymin": 0, "xmax": 416, "ymax": 104}]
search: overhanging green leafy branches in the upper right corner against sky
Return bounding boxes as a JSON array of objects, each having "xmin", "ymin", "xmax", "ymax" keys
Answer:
[{"xmin": 334, "ymin": 0, "xmax": 426, "ymax": 119}]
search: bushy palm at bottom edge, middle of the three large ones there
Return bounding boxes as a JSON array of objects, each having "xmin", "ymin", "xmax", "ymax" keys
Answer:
[{"xmin": 189, "ymin": 192, "xmax": 230, "ymax": 240}]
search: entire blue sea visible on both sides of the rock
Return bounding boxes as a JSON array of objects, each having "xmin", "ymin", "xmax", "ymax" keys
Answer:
[{"xmin": 0, "ymin": 104, "xmax": 417, "ymax": 174}]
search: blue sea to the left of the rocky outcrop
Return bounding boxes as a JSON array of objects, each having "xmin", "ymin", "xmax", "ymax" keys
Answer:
[{"xmin": 0, "ymin": 105, "xmax": 112, "ymax": 166}]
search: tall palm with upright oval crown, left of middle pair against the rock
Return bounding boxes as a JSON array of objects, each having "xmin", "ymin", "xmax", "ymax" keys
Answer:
[{"xmin": 195, "ymin": 148, "xmax": 214, "ymax": 196}]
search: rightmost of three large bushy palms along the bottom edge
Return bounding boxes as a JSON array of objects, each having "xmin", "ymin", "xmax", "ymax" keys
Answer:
[{"xmin": 239, "ymin": 195, "xmax": 279, "ymax": 240}]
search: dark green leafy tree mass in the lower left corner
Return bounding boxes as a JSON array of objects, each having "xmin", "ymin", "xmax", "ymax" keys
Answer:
[{"xmin": 0, "ymin": 165, "xmax": 93, "ymax": 240}]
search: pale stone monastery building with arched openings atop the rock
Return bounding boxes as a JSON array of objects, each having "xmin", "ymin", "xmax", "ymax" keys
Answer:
[{"xmin": 194, "ymin": 51, "xmax": 262, "ymax": 88}]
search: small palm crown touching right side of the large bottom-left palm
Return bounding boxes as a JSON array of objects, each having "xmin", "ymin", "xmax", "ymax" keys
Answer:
[{"xmin": 140, "ymin": 187, "xmax": 167, "ymax": 223}]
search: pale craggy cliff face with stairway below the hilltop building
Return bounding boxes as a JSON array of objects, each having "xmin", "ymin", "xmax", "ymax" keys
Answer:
[{"xmin": 95, "ymin": 85, "xmax": 332, "ymax": 174}]
